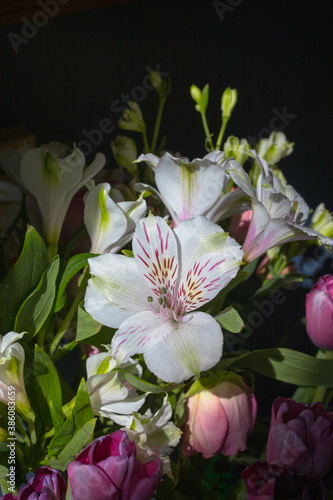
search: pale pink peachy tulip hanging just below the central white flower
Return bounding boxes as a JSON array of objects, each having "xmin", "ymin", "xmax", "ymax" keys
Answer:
[{"xmin": 182, "ymin": 380, "xmax": 257, "ymax": 458}]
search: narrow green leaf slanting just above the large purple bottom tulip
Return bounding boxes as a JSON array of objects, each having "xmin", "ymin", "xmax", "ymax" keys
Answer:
[{"xmin": 46, "ymin": 418, "xmax": 97, "ymax": 471}]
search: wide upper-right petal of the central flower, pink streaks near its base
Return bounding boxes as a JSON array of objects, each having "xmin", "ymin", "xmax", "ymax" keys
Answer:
[{"xmin": 174, "ymin": 216, "xmax": 243, "ymax": 314}]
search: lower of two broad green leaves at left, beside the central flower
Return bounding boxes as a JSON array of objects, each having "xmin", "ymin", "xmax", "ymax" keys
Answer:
[{"xmin": 14, "ymin": 255, "xmax": 59, "ymax": 340}]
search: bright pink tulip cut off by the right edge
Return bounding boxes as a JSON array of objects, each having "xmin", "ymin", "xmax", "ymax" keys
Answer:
[{"xmin": 305, "ymin": 274, "xmax": 333, "ymax": 350}]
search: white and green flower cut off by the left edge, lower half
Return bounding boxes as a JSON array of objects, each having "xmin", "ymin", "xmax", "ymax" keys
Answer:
[{"xmin": 0, "ymin": 332, "xmax": 34, "ymax": 420}]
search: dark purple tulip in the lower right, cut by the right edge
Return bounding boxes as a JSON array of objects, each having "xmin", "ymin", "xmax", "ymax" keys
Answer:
[{"xmin": 266, "ymin": 397, "xmax": 333, "ymax": 478}]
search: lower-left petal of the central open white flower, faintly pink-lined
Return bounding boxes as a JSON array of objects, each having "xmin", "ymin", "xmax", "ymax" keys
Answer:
[{"xmin": 111, "ymin": 311, "xmax": 175, "ymax": 363}]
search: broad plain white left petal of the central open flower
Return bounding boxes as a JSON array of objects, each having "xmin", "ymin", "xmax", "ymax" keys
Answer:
[{"xmin": 85, "ymin": 254, "xmax": 151, "ymax": 328}]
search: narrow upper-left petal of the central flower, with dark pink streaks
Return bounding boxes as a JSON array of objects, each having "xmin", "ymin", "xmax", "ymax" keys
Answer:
[{"xmin": 133, "ymin": 216, "xmax": 178, "ymax": 304}]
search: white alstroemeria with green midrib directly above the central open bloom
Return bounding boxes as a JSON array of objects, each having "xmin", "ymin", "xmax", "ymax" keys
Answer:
[{"xmin": 137, "ymin": 151, "xmax": 244, "ymax": 226}]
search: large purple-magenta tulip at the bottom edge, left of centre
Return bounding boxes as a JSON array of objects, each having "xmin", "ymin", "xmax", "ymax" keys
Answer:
[{"xmin": 67, "ymin": 431, "xmax": 163, "ymax": 500}]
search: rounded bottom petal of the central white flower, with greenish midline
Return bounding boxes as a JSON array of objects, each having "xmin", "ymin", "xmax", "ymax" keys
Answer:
[{"xmin": 144, "ymin": 312, "xmax": 223, "ymax": 382}]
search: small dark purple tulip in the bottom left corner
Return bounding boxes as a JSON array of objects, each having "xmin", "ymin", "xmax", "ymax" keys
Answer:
[{"xmin": 17, "ymin": 467, "xmax": 67, "ymax": 500}]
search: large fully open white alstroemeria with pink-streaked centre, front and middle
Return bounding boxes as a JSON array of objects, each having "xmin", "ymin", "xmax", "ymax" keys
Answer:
[{"xmin": 85, "ymin": 215, "xmax": 243, "ymax": 382}]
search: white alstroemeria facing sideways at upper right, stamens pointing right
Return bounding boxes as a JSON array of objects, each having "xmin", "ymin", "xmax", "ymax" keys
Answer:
[{"xmin": 227, "ymin": 151, "xmax": 333, "ymax": 262}]
